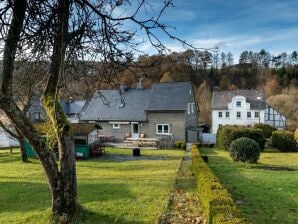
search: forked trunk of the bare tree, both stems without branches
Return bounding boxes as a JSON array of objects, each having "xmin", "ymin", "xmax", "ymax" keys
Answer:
[{"xmin": 0, "ymin": 0, "xmax": 77, "ymax": 220}]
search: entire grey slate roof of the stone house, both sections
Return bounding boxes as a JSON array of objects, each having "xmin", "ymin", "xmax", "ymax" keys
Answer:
[{"xmin": 81, "ymin": 82, "xmax": 193, "ymax": 121}]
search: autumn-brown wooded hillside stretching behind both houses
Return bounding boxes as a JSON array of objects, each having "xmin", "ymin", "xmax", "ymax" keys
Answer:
[{"xmin": 9, "ymin": 50, "xmax": 298, "ymax": 129}]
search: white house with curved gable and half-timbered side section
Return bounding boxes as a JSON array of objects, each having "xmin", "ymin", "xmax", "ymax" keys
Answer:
[{"xmin": 211, "ymin": 90, "xmax": 286, "ymax": 134}]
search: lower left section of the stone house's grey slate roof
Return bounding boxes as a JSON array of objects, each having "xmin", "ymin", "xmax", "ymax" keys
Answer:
[{"xmin": 81, "ymin": 89, "xmax": 151, "ymax": 121}]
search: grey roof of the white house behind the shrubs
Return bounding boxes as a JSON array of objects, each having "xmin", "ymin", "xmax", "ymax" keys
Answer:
[{"xmin": 211, "ymin": 90, "xmax": 266, "ymax": 110}]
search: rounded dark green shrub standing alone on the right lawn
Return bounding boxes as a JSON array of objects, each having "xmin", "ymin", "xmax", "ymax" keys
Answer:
[{"xmin": 230, "ymin": 137, "xmax": 261, "ymax": 163}]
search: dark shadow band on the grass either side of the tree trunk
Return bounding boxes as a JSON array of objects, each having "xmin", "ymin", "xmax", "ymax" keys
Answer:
[{"xmin": 0, "ymin": 182, "xmax": 134, "ymax": 214}]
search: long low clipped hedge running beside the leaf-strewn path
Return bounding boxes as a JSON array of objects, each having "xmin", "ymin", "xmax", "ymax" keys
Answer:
[{"xmin": 191, "ymin": 145, "xmax": 248, "ymax": 224}]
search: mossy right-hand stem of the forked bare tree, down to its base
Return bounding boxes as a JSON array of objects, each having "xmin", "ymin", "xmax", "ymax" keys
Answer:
[{"xmin": 42, "ymin": 0, "xmax": 77, "ymax": 215}]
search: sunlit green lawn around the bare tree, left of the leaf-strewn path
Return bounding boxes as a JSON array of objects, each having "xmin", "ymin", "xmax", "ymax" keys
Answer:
[{"xmin": 0, "ymin": 148, "xmax": 184, "ymax": 224}]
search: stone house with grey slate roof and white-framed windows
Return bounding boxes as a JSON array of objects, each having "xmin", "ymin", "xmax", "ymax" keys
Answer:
[{"xmin": 81, "ymin": 82, "xmax": 198, "ymax": 140}]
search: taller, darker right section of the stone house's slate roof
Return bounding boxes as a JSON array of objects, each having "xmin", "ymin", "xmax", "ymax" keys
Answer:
[{"xmin": 146, "ymin": 82, "xmax": 193, "ymax": 111}]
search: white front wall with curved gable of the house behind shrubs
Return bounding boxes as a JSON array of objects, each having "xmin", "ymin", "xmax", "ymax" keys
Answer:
[{"xmin": 212, "ymin": 96, "xmax": 265, "ymax": 134}]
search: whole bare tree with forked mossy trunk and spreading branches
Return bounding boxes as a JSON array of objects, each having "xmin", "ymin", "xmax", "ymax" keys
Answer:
[{"xmin": 0, "ymin": 0, "xmax": 188, "ymax": 221}]
